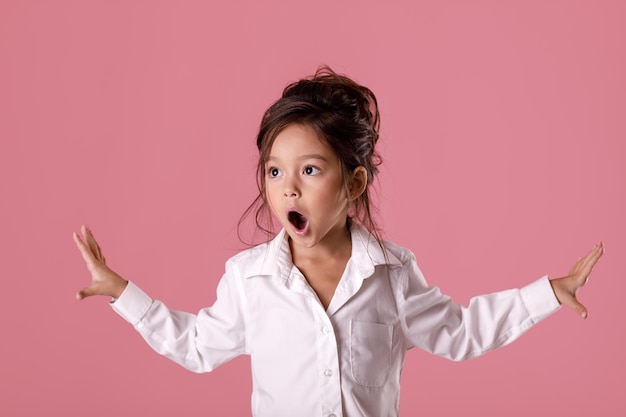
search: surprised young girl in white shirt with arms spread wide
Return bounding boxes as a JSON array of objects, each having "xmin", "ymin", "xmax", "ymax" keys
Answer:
[{"xmin": 74, "ymin": 67, "xmax": 603, "ymax": 417}]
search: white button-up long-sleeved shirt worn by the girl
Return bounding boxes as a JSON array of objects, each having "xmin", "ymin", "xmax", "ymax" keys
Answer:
[{"xmin": 111, "ymin": 225, "xmax": 559, "ymax": 417}]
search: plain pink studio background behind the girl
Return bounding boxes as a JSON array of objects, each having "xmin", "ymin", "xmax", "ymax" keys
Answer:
[{"xmin": 0, "ymin": 0, "xmax": 626, "ymax": 417}]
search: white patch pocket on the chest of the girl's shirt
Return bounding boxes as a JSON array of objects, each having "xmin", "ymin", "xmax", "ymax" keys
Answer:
[{"xmin": 350, "ymin": 321, "xmax": 393, "ymax": 388}]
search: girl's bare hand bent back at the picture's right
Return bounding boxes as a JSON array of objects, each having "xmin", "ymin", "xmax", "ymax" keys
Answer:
[{"xmin": 550, "ymin": 242, "xmax": 604, "ymax": 319}]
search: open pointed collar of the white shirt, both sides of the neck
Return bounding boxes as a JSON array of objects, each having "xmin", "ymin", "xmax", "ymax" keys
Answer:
[{"xmin": 241, "ymin": 223, "xmax": 402, "ymax": 282}]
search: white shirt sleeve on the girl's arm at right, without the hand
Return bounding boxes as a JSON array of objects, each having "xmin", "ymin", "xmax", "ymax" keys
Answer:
[{"xmin": 396, "ymin": 250, "xmax": 559, "ymax": 361}]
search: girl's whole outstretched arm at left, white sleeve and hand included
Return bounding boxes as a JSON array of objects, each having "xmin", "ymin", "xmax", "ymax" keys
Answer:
[{"xmin": 74, "ymin": 226, "xmax": 246, "ymax": 372}]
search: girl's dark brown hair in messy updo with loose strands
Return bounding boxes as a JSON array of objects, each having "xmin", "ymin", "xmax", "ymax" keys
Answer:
[{"xmin": 238, "ymin": 66, "xmax": 382, "ymax": 243}]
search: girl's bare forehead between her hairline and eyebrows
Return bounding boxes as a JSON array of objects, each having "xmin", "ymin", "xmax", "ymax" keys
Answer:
[{"xmin": 267, "ymin": 124, "xmax": 337, "ymax": 162}]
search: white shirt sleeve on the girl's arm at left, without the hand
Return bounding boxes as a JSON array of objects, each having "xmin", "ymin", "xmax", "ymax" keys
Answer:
[{"xmin": 111, "ymin": 266, "xmax": 246, "ymax": 372}]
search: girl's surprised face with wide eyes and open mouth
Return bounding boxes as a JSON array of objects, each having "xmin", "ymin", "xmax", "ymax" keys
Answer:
[{"xmin": 265, "ymin": 124, "xmax": 349, "ymax": 252}]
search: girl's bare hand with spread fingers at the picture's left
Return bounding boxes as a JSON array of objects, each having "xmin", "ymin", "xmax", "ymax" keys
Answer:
[{"xmin": 73, "ymin": 225, "xmax": 128, "ymax": 300}]
